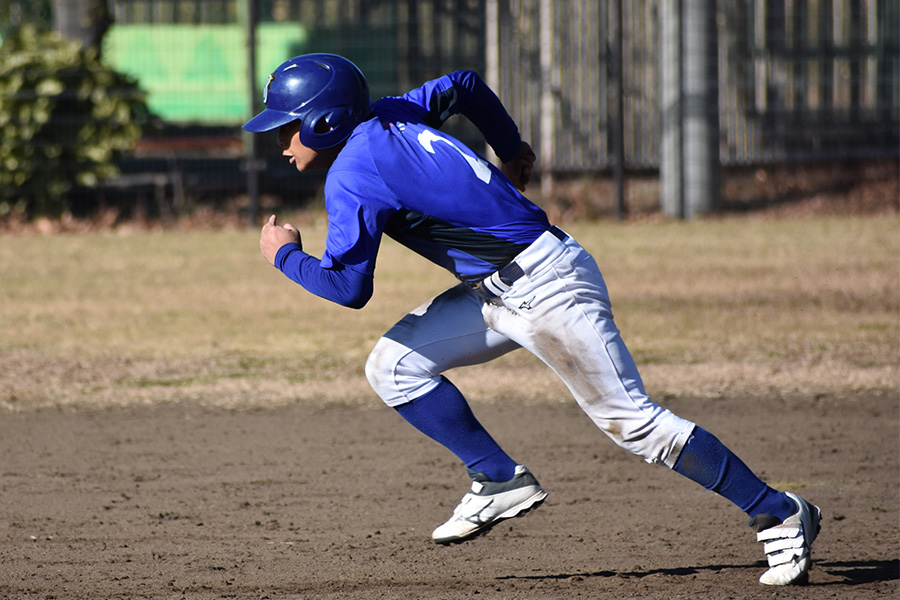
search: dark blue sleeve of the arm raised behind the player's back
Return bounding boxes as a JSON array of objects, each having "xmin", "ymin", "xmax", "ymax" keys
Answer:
[{"xmin": 384, "ymin": 71, "xmax": 522, "ymax": 161}]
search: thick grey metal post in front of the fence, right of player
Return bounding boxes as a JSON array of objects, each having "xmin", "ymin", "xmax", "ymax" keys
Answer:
[{"xmin": 660, "ymin": 0, "xmax": 720, "ymax": 219}]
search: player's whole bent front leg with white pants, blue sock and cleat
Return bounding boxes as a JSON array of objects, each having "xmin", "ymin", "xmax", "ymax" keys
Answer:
[{"xmin": 366, "ymin": 285, "xmax": 547, "ymax": 543}]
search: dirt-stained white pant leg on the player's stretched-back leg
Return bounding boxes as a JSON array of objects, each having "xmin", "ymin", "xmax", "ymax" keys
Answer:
[{"xmin": 482, "ymin": 230, "xmax": 694, "ymax": 468}]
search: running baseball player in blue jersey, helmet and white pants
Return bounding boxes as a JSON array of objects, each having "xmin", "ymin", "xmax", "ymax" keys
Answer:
[{"xmin": 244, "ymin": 54, "xmax": 821, "ymax": 585}]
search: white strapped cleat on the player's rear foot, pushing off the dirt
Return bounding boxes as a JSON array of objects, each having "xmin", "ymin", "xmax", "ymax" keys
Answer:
[{"xmin": 750, "ymin": 492, "xmax": 822, "ymax": 585}]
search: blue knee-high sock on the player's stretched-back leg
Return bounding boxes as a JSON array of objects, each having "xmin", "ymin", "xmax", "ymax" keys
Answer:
[{"xmin": 675, "ymin": 427, "xmax": 797, "ymax": 521}]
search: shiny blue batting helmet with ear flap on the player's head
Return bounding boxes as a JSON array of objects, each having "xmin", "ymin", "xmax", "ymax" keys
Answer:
[{"xmin": 244, "ymin": 54, "xmax": 372, "ymax": 150}]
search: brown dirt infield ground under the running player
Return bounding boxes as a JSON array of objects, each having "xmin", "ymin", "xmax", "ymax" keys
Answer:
[{"xmin": 0, "ymin": 394, "xmax": 900, "ymax": 600}]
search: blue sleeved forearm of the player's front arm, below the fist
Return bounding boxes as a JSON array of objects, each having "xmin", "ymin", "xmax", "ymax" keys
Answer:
[{"xmin": 275, "ymin": 244, "xmax": 373, "ymax": 308}]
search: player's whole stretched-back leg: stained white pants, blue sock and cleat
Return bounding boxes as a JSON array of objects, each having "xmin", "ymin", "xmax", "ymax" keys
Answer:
[{"xmin": 484, "ymin": 229, "xmax": 819, "ymax": 583}]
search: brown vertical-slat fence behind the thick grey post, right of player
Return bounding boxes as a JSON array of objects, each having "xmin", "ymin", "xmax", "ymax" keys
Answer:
[{"xmin": 488, "ymin": 0, "xmax": 900, "ymax": 172}]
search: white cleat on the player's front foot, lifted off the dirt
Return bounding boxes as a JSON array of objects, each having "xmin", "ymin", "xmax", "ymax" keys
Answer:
[{"xmin": 431, "ymin": 465, "xmax": 547, "ymax": 544}]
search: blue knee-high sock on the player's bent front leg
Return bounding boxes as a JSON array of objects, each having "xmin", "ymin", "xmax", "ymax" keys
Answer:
[{"xmin": 395, "ymin": 377, "xmax": 516, "ymax": 481}]
